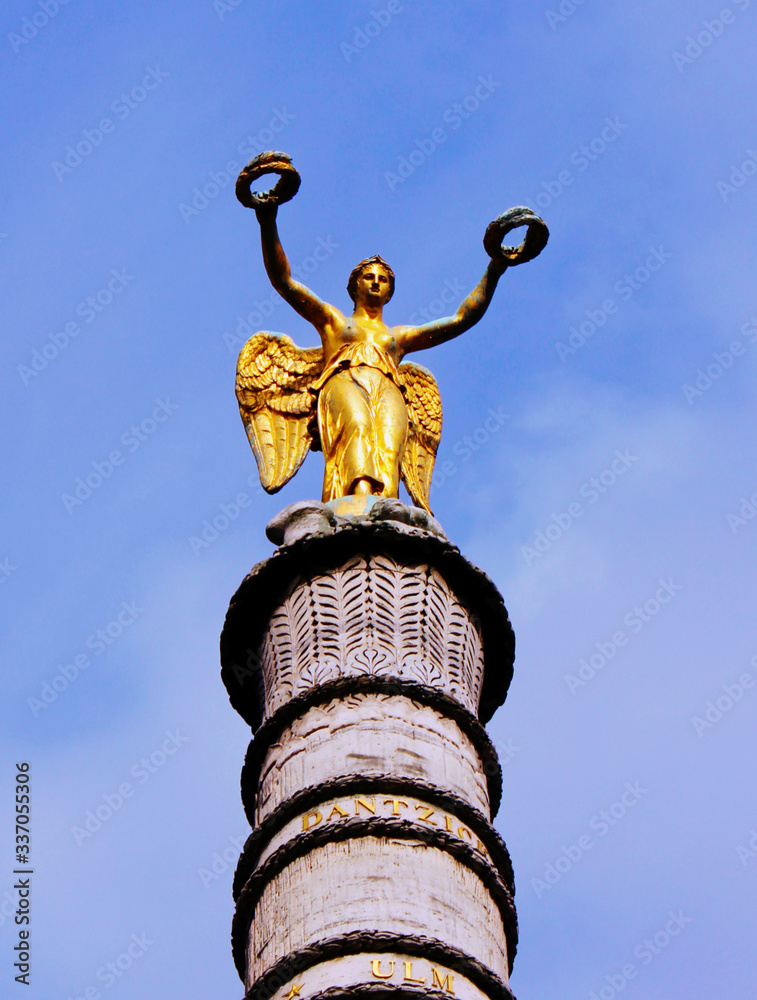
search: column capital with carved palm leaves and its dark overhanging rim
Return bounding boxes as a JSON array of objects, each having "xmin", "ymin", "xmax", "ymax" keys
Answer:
[{"xmin": 221, "ymin": 516, "xmax": 515, "ymax": 728}]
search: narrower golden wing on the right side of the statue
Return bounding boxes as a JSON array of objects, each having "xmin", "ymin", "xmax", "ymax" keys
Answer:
[{"xmin": 397, "ymin": 362, "xmax": 442, "ymax": 514}]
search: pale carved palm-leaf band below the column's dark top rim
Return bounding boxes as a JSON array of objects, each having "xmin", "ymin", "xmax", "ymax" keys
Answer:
[{"xmin": 255, "ymin": 555, "xmax": 483, "ymax": 714}]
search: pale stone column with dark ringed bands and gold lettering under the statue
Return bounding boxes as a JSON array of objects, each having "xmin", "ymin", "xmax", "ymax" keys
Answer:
[{"xmin": 221, "ymin": 500, "xmax": 517, "ymax": 1000}]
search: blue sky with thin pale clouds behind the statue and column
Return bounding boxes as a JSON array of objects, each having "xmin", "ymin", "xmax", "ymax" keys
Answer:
[{"xmin": 0, "ymin": 0, "xmax": 757, "ymax": 1000}]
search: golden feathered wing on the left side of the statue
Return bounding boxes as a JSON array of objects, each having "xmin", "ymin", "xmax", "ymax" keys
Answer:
[{"xmin": 236, "ymin": 333, "xmax": 323, "ymax": 493}]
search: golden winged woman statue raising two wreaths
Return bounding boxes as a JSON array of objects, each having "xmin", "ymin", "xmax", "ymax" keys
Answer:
[{"xmin": 236, "ymin": 152, "xmax": 549, "ymax": 513}]
